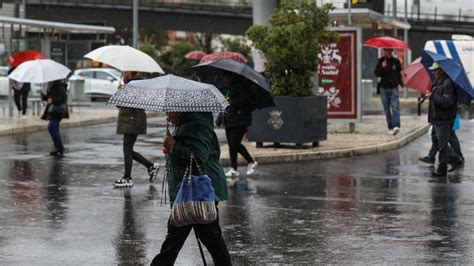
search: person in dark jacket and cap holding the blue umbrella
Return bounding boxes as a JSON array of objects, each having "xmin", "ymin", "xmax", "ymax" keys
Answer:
[{"xmin": 426, "ymin": 62, "xmax": 457, "ymax": 176}]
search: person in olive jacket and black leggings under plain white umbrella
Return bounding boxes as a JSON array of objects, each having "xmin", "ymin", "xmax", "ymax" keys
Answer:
[{"xmin": 114, "ymin": 71, "xmax": 160, "ymax": 187}]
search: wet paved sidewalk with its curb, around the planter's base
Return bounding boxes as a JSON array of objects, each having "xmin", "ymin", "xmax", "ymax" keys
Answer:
[{"xmin": 221, "ymin": 115, "xmax": 429, "ymax": 166}]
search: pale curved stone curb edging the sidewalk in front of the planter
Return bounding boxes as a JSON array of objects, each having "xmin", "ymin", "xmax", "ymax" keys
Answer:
[{"xmin": 220, "ymin": 124, "xmax": 429, "ymax": 167}]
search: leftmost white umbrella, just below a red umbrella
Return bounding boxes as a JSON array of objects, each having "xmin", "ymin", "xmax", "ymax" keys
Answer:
[{"xmin": 8, "ymin": 59, "xmax": 71, "ymax": 83}]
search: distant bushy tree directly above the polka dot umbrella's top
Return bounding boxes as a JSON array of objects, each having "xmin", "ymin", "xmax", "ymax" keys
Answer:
[{"xmin": 161, "ymin": 42, "xmax": 199, "ymax": 77}]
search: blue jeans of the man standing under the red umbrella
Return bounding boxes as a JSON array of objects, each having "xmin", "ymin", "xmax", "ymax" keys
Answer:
[{"xmin": 380, "ymin": 88, "xmax": 400, "ymax": 129}]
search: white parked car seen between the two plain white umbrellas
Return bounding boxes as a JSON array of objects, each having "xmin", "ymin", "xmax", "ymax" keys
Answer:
[{"xmin": 69, "ymin": 68, "xmax": 121, "ymax": 100}]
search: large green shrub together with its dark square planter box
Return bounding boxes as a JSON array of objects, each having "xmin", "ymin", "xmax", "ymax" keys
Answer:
[{"xmin": 246, "ymin": 0, "xmax": 338, "ymax": 147}]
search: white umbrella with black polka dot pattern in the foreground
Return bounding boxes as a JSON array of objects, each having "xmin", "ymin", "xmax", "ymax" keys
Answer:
[{"xmin": 107, "ymin": 75, "xmax": 229, "ymax": 112}]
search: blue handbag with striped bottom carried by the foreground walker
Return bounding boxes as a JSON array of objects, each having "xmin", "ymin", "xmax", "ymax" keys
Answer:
[{"xmin": 170, "ymin": 153, "xmax": 217, "ymax": 227}]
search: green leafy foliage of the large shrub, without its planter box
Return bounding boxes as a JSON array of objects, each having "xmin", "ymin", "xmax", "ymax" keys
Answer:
[{"xmin": 246, "ymin": 0, "xmax": 338, "ymax": 96}]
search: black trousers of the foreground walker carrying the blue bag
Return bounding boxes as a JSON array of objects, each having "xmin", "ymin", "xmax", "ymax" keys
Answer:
[{"xmin": 151, "ymin": 206, "xmax": 232, "ymax": 266}]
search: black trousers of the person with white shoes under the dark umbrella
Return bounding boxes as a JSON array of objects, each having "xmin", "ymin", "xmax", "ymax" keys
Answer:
[{"xmin": 225, "ymin": 127, "xmax": 254, "ymax": 169}]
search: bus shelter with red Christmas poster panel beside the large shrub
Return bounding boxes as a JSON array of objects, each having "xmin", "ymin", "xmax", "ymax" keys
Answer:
[{"xmin": 315, "ymin": 8, "xmax": 410, "ymax": 125}]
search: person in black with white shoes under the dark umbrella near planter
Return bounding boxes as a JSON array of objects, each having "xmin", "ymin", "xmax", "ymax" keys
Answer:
[{"xmin": 216, "ymin": 72, "xmax": 257, "ymax": 177}]
